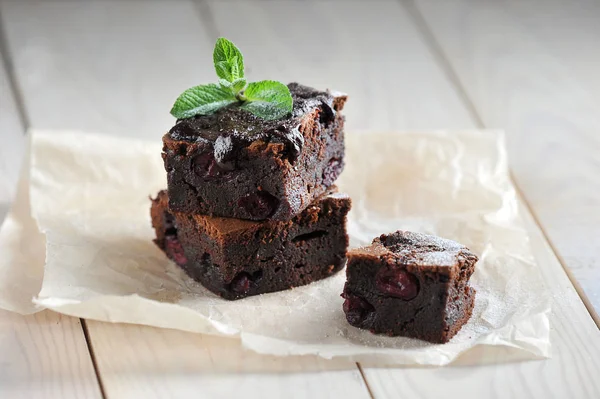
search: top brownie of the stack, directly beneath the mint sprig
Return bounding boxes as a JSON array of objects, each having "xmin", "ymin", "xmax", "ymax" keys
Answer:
[{"xmin": 163, "ymin": 83, "xmax": 346, "ymax": 221}]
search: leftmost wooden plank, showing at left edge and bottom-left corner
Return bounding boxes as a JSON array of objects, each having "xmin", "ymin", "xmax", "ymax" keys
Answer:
[{"xmin": 0, "ymin": 22, "xmax": 102, "ymax": 399}]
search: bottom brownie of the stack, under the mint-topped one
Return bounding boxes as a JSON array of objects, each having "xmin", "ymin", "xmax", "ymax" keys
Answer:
[{"xmin": 151, "ymin": 186, "xmax": 350, "ymax": 299}]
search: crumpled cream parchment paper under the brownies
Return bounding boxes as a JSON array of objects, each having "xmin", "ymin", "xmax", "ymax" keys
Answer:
[{"xmin": 0, "ymin": 131, "xmax": 550, "ymax": 365}]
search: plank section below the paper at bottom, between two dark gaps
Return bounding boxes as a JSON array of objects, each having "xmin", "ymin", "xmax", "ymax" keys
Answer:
[{"xmin": 87, "ymin": 321, "xmax": 369, "ymax": 399}]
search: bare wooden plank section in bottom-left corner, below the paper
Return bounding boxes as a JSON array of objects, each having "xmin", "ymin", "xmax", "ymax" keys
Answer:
[{"xmin": 0, "ymin": 310, "xmax": 102, "ymax": 399}]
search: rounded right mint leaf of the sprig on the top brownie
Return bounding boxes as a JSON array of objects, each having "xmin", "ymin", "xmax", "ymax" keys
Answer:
[{"xmin": 242, "ymin": 80, "xmax": 293, "ymax": 120}]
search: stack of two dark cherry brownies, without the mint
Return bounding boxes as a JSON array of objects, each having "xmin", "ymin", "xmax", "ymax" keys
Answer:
[{"xmin": 151, "ymin": 83, "xmax": 350, "ymax": 299}]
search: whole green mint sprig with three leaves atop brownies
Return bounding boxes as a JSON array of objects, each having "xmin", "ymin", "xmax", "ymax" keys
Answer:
[{"xmin": 171, "ymin": 38, "xmax": 293, "ymax": 120}]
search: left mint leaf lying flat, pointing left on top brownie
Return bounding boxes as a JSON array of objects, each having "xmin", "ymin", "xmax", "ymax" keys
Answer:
[{"xmin": 171, "ymin": 83, "xmax": 238, "ymax": 119}]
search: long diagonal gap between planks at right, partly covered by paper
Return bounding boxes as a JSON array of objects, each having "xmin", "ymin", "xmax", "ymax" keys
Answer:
[{"xmin": 398, "ymin": 0, "xmax": 600, "ymax": 329}]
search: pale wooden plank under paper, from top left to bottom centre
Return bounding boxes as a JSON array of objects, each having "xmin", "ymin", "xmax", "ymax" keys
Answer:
[{"xmin": 2, "ymin": 1, "xmax": 369, "ymax": 398}]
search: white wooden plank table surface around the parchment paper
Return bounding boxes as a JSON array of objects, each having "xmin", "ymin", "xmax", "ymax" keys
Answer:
[{"xmin": 0, "ymin": 0, "xmax": 600, "ymax": 399}]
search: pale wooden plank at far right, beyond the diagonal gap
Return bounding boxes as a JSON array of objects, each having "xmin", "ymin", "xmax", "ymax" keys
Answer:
[{"xmin": 417, "ymin": 0, "xmax": 600, "ymax": 318}]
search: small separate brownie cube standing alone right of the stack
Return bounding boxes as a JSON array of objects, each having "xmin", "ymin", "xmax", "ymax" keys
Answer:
[{"xmin": 342, "ymin": 231, "xmax": 478, "ymax": 343}]
